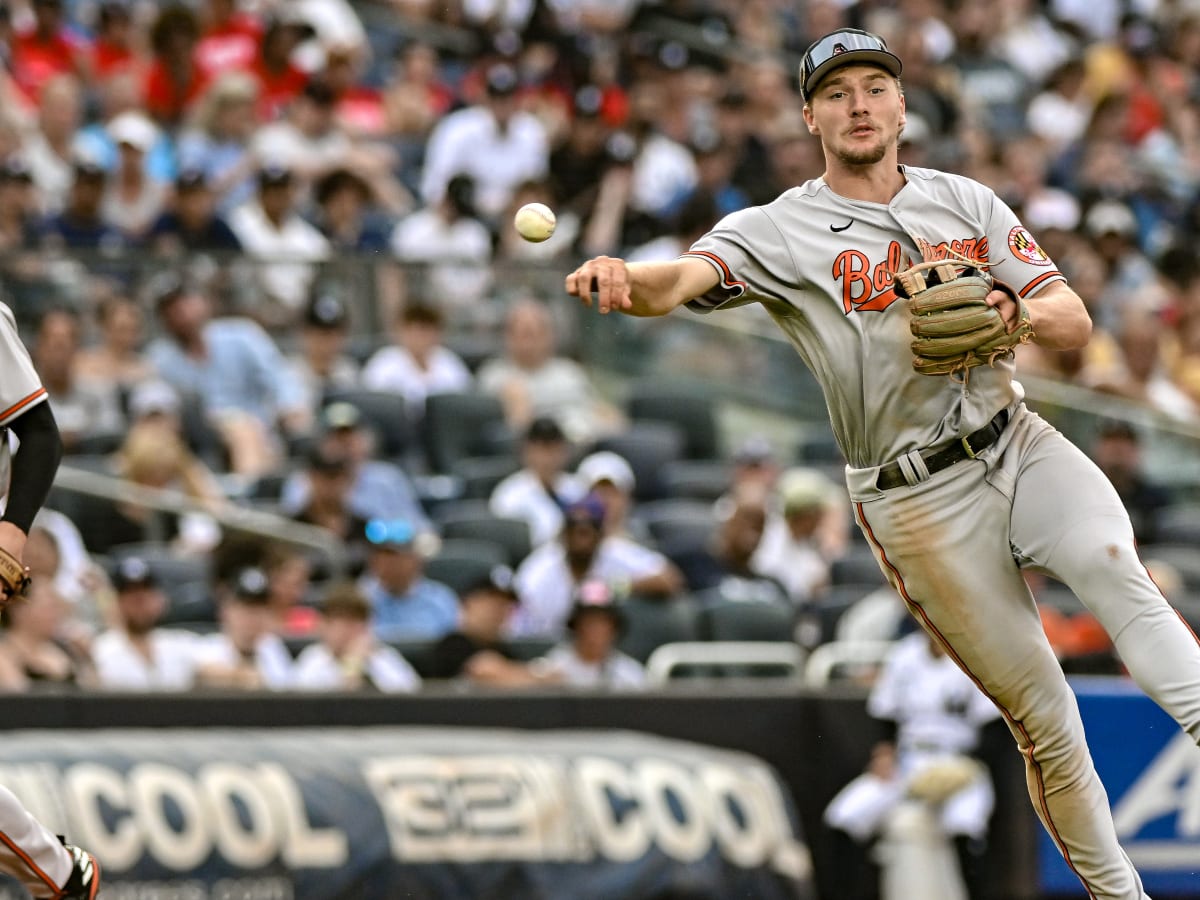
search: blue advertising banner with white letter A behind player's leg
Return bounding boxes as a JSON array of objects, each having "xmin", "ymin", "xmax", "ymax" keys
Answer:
[{"xmin": 1038, "ymin": 678, "xmax": 1200, "ymax": 900}]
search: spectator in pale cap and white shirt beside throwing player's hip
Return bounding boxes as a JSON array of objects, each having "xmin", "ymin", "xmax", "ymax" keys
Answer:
[{"xmin": 750, "ymin": 469, "xmax": 836, "ymax": 606}]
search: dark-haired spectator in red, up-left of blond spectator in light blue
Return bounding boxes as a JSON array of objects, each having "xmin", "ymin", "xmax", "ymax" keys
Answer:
[{"xmin": 144, "ymin": 4, "xmax": 206, "ymax": 128}]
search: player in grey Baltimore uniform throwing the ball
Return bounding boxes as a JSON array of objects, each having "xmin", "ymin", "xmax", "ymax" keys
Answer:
[{"xmin": 566, "ymin": 29, "xmax": 1200, "ymax": 900}]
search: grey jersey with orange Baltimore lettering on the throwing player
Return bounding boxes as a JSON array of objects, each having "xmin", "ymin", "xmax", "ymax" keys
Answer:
[{"xmin": 685, "ymin": 168, "xmax": 1062, "ymax": 467}]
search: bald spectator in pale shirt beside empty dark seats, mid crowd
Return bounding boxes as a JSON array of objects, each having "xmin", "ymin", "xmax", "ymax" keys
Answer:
[{"xmin": 478, "ymin": 299, "xmax": 623, "ymax": 443}]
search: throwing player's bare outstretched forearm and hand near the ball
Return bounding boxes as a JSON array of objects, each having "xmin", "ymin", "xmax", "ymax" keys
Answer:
[{"xmin": 566, "ymin": 257, "xmax": 718, "ymax": 316}]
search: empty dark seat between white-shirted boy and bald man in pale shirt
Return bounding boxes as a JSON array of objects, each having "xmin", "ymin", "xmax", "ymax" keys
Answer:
[{"xmin": 424, "ymin": 391, "xmax": 512, "ymax": 474}]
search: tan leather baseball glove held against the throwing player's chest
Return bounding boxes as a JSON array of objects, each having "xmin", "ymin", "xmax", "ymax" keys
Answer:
[{"xmin": 893, "ymin": 259, "xmax": 1033, "ymax": 376}]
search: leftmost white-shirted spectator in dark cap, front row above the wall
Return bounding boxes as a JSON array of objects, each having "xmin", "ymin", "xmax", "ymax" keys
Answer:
[{"xmin": 91, "ymin": 556, "xmax": 203, "ymax": 691}]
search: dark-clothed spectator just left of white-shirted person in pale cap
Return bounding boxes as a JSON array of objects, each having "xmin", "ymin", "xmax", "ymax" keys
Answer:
[{"xmin": 674, "ymin": 487, "xmax": 791, "ymax": 606}]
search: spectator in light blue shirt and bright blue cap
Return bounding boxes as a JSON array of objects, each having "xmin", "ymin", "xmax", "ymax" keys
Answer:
[{"xmin": 359, "ymin": 518, "xmax": 458, "ymax": 641}]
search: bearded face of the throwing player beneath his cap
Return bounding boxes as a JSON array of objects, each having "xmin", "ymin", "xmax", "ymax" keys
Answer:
[{"xmin": 804, "ymin": 66, "xmax": 905, "ymax": 168}]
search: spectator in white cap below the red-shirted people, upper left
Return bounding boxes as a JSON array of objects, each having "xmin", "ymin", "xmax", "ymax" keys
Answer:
[{"xmin": 101, "ymin": 110, "xmax": 168, "ymax": 244}]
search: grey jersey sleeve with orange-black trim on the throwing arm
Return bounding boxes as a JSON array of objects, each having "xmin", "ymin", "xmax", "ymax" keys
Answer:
[{"xmin": 683, "ymin": 206, "xmax": 797, "ymax": 313}]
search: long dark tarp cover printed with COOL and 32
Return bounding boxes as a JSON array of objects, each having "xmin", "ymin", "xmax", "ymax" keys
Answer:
[{"xmin": 0, "ymin": 727, "xmax": 811, "ymax": 900}]
